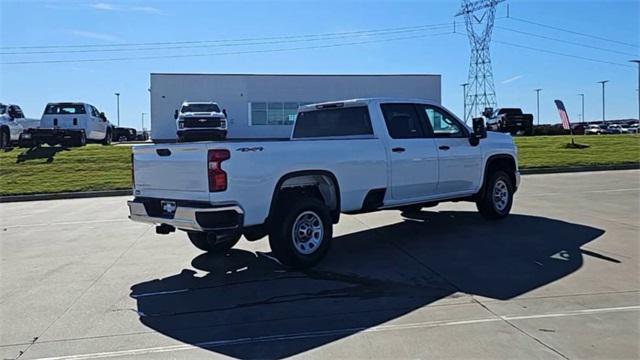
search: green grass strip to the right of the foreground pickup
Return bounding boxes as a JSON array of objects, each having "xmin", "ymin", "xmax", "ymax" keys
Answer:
[{"xmin": 515, "ymin": 135, "xmax": 640, "ymax": 169}]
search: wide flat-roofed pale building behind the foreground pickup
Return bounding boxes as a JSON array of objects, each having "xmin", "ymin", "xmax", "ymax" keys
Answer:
[{"xmin": 149, "ymin": 73, "xmax": 441, "ymax": 141}]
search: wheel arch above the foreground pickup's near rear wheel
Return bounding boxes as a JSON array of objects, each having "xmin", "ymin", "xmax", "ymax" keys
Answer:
[{"xmin": 265, "ymin": 170, "xmax": 341, "ymax": 224}]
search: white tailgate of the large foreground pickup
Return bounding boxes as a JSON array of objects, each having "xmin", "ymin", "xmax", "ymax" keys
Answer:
[{"xmin": 132, "ymin": 143, "xmax": 209, "ymax": 200}]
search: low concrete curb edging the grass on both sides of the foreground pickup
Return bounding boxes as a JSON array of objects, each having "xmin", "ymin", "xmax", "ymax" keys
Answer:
[{"xmin": 0, "ymin": 163, "xmax": 640, "ymax": 203}]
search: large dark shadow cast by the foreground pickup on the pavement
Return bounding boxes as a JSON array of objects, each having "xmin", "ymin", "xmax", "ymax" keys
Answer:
[{"xmin": 131, "ymin": 211, "xmax": 618, "ymax": 358}]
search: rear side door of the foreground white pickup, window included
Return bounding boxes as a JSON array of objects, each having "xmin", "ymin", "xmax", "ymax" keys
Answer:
[{"xmin": 380, "ymin": 103, "xmax": 438, "ymax": 201}]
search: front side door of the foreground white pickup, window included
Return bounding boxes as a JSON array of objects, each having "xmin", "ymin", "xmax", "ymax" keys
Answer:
[{"xmin": 420, "ymin": 105, "xmax": 482, "ymax": 195}]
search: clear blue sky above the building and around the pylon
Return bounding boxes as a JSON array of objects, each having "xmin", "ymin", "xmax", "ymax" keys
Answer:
[{"xmin": 0, "ymin": 0, "xmax": 640, "ymax": 128}]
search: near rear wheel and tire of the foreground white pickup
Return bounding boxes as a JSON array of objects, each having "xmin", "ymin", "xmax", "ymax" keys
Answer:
[{"xmin": 269, "ymin": 196, "xmax": 333, "ymax": 269}]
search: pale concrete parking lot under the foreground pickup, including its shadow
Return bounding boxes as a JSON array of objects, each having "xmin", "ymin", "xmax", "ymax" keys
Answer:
[{"xmin": 0, "ymin": 170, "xmax": 640, "ymax": 359}]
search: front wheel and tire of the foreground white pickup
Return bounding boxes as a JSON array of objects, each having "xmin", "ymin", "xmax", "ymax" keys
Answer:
[{"xmin": 476, "ymin": 170, "xmax": 514, "ymax": 220}]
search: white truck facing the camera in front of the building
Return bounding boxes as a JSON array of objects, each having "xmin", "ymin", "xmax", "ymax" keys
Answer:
[{"xmin": 174, "ymin": 101, "xmax": 227, "ymax": 142}]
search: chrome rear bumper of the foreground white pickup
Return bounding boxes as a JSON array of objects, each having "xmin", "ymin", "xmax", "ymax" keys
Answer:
[{"xmin": 127, "ymin": 198, "xmax": 244, "ymax": 232}]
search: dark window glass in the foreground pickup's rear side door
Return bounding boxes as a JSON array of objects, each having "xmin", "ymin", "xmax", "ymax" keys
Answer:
[{"xmin": 380, "ymin": 104, "xmax": 425, "ymax": 139}]
